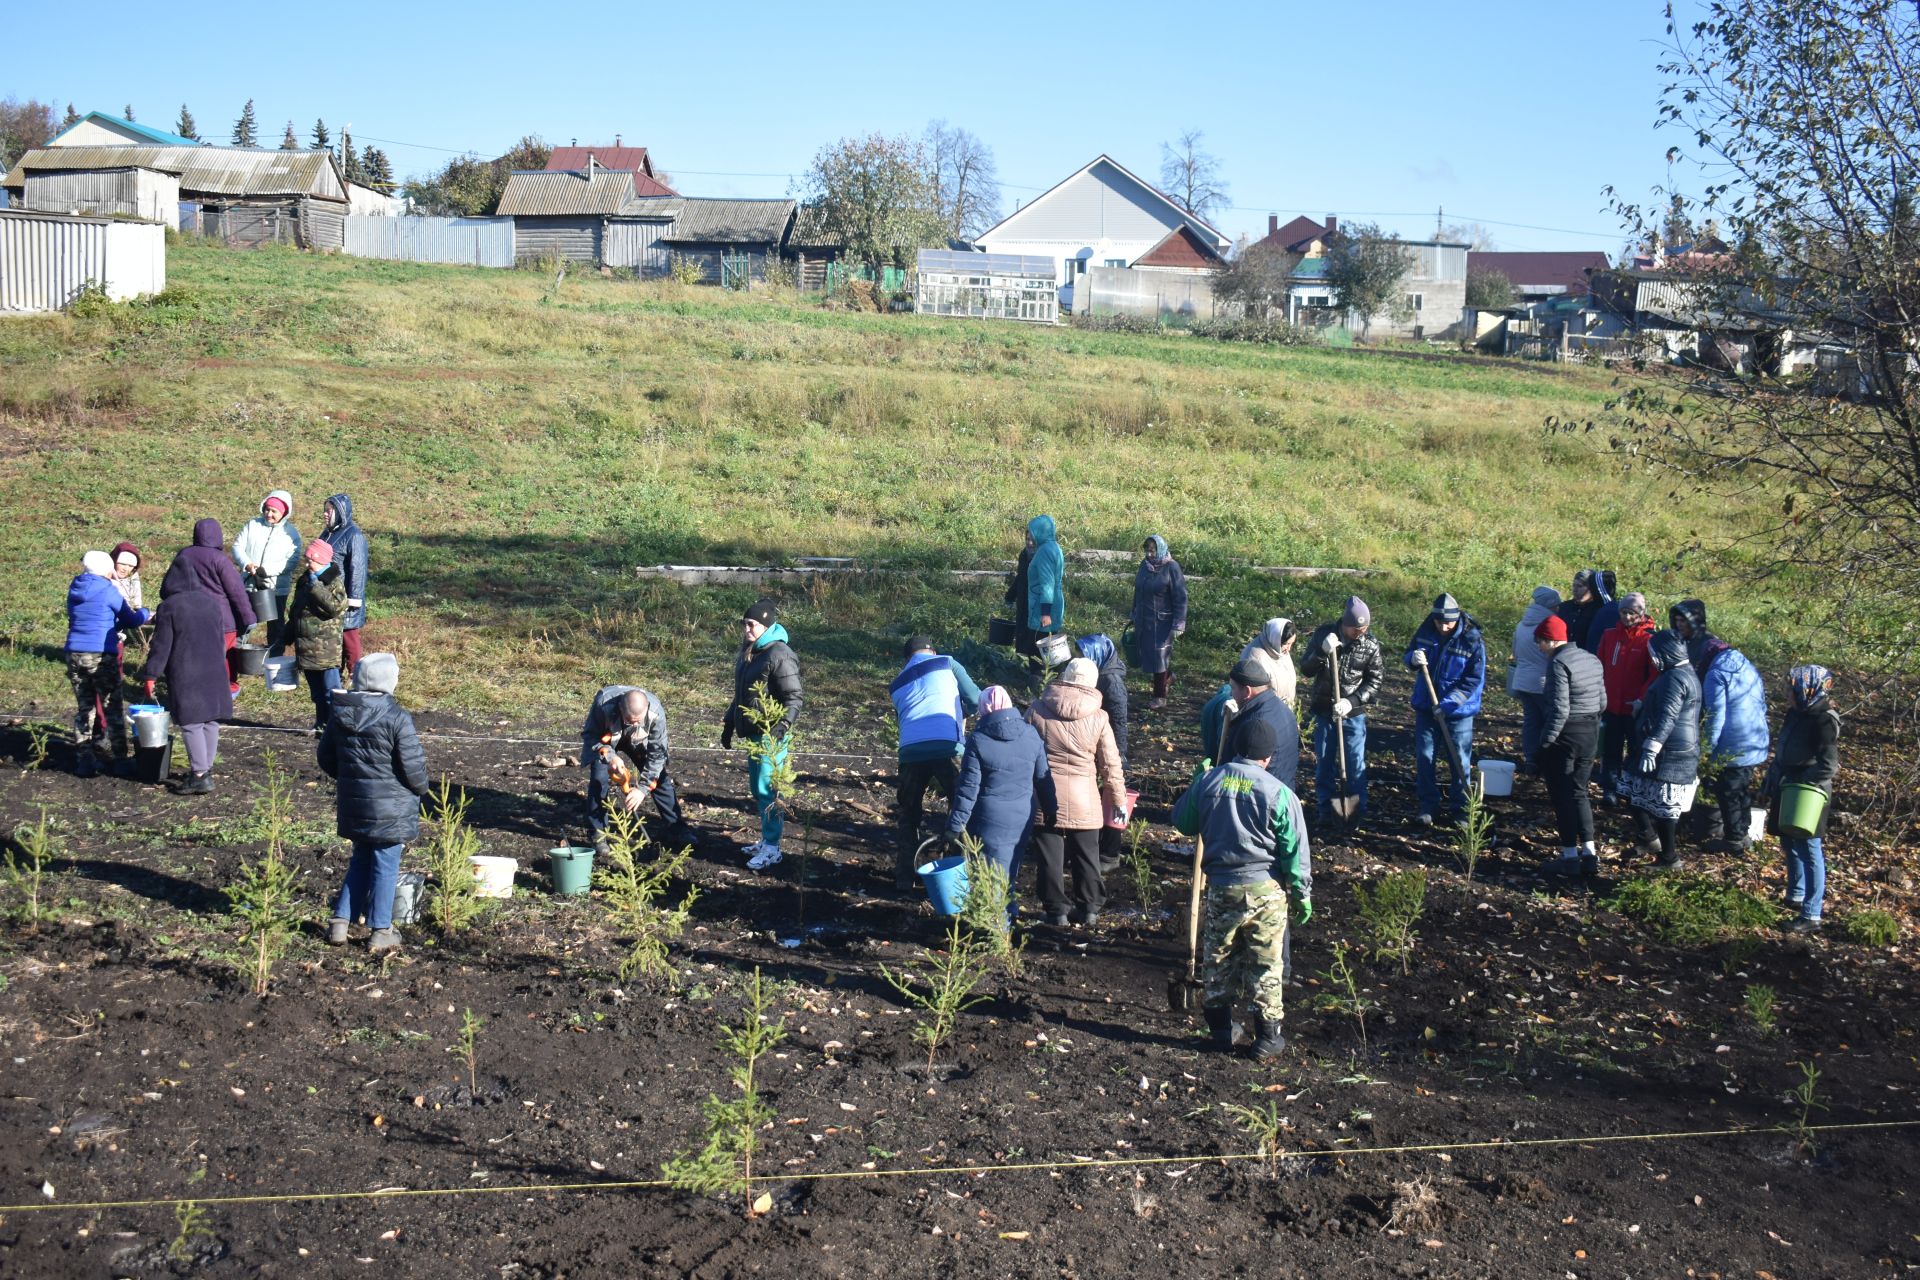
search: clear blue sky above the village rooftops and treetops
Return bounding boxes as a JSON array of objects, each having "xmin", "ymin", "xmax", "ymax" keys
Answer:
[{"xmin": 11, "ymin": 0, "xmax": 1697, "ymax": 251}]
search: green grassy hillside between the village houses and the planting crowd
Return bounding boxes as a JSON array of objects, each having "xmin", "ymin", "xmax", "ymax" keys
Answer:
[{"xmin": 0, "ymin": 242, "xmax": 1807, "ymax": 714}]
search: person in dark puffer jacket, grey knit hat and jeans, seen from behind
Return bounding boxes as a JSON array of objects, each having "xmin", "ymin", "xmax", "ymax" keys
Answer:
[{"xmin": 317, "ymin": 652, "xmax": 428, "ymax": 952}]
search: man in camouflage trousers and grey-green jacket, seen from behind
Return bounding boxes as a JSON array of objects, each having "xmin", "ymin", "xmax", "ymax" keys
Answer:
[{"xmin": 1173, "ymin": 722, "xmax": 1313, "ymax": 1057}]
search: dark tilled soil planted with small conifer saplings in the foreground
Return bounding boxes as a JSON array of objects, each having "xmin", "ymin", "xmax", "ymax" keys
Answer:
[{"xmin": 0, "ymin": 690, "xmax": 1920, "ymax": 1280}]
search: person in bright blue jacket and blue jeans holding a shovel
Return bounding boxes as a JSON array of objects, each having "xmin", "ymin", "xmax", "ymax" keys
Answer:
[{"xmin": 1402, "ymin": 591, "xmax": 1486, "ymax": 827}]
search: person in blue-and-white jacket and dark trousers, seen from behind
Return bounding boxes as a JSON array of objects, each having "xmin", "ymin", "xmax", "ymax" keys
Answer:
[{"xmin": 887, "ymin": 635, "xmax": 979, "ymax": 889}]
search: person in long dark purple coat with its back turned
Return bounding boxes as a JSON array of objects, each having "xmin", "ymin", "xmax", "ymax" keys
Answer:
[{"xmin": 146, "ymin": 564, "xmax": 234, "ymax": 796}]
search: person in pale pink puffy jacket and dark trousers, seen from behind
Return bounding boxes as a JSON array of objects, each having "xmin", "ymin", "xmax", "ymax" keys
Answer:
[{"xmin": 1027, "ymin": 658, "xmax": 1127, "ymax": 925}]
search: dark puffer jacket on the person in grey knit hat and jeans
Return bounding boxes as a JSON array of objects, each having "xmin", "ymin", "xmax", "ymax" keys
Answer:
[{"xmin": 319, "ymin": 691, "xmax": 428, "ymax": 844}]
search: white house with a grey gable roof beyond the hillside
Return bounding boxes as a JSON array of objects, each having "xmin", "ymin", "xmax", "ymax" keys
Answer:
[{"xmin": 973, "ymin": 155, "xmax": 1231, "ymax": 309}]
